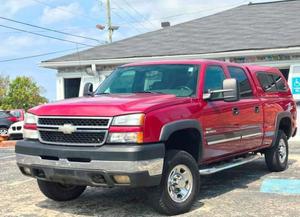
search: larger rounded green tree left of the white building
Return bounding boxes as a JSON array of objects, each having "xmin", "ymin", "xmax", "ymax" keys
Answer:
[{"xmin": 2, "ymin": 76, "xmax": 47, "ymax": 110}]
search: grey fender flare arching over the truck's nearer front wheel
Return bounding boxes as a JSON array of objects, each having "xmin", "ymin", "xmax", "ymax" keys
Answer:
[{"xmin": 159, "ymin": 119, "xmax": 204, "ymax": 160}]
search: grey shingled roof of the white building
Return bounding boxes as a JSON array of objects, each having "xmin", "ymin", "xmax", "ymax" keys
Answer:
[{"xmin": 45, "ymin": 0, "xmax": 300, "ymax": 62}]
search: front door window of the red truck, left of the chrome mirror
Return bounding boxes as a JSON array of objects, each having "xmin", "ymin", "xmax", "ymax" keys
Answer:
[{"xmin": 203, "ymin": 65, "xmax": 226, "ymax": 98}]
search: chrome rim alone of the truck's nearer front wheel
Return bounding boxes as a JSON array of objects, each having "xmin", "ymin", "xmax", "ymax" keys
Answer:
[{"xmin": 168, "ymin": 164, "xmax": 193, "ymax": 203}]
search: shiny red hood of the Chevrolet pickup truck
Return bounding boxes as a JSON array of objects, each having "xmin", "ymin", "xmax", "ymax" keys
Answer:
[{"xmin": 29, "ymin": 94, "xmax": 191, "ymax": 117}]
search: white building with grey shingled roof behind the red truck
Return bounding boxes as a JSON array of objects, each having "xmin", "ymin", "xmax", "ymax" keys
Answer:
[{"xmin": 41, "ymin": 0, "xmax": 300, "ymax": 101}]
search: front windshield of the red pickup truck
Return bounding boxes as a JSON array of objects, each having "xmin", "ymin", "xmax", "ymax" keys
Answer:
[{"xmin": 95, "ymin": 64, "xmax": 199, "ymax": 97}]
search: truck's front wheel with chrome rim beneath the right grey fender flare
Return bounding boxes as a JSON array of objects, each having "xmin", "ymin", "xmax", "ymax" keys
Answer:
[{"xmin": 151, "ymin": 150, "xmax": 200, "ymax": 215}]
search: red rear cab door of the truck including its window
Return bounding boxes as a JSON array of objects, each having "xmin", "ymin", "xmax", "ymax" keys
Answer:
[{"xmin": 228, "ymin": 66, "xmax": 263, "ymax": 151}]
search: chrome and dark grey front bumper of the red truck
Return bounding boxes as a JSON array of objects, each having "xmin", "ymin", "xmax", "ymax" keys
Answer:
[{"xmin": 16, "ymin": 140, "xmax": 165, "ymax": 187}]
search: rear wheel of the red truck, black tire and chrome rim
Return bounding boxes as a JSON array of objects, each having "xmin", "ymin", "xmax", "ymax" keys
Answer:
[{"xmin": 265, "ymin": 130, "xmax": 289, "ymax": 172}]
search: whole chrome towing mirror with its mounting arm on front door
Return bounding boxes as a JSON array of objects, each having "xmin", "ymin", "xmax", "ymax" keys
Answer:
[{"xmin": 203, "ymin": 78, "xmax": 240, "ymax": 102}]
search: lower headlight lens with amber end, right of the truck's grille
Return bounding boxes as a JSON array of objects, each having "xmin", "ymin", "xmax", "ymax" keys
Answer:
[{"xmin": 108, "ymin": 132, "xmax": 143, "ymax": 143}]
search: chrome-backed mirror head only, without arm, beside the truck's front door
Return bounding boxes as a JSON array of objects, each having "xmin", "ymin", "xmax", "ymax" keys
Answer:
[{"xmin": 223, "ymin": 78, "xmax": 240, "ymax": 102}]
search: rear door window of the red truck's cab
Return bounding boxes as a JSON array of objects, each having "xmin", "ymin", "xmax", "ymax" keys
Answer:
[{"xmin": 228, "ymin": 66, "xmax": 253, "ymax": 98}]
